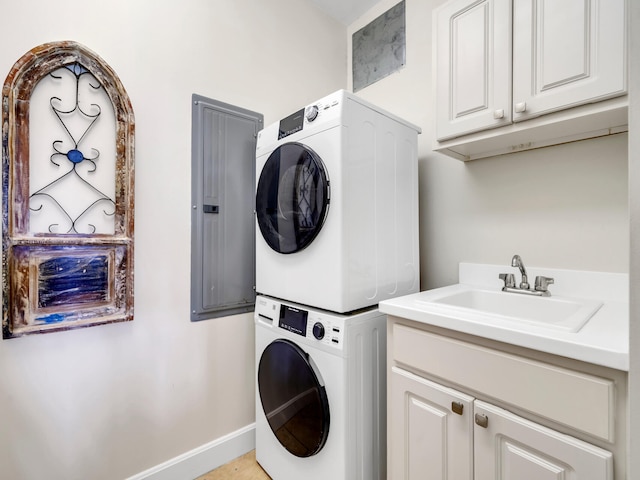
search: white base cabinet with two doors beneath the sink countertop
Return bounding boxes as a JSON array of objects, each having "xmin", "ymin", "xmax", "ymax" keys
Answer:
[{"xmin": 387, "ymin": 316, "xmax": 626, "ymax": 480}]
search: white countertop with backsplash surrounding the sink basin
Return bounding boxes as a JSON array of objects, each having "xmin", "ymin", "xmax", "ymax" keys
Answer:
[{"xmin": 379, "ymin": 263, "xmax": 629, "ymax": 371}]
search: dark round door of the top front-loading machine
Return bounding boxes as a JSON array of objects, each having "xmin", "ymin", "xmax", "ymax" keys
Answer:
[{"xmin": 256, "ymin": 142, "xmax": 329, "ymax": 253}]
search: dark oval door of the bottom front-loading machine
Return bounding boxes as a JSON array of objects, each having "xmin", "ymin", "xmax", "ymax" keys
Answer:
[{"xmin": 258, "ymin": 339, "xmax": 329, "ymax": 457}]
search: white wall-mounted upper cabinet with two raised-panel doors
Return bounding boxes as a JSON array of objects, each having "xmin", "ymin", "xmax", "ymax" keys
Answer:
[{"xmin": 434, "ymin": 0, "xmax": 627, "ymax": 160}]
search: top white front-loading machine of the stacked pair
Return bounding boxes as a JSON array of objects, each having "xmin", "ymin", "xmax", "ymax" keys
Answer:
[{"xmin": 256, "ymin": 90, "xmax": 420, "ymax": 313}]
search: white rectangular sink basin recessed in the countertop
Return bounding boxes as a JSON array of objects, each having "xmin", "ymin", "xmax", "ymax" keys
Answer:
[{"xmin": 422, "ymin": 289, "xmax": 602, "ymax": 332}]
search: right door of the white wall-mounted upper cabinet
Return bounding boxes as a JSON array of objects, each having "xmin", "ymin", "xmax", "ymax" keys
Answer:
[{"xmin": 513, "ymin": 0, "xmax": 626, "ymax": 122}]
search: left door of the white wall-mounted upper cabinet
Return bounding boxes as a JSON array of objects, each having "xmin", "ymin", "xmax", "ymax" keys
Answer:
[{"xmin": 433, "ymin": 0, "xmax": 511, "ymax": 140}]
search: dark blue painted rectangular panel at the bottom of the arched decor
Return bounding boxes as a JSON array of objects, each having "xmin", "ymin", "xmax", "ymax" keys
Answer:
[{"xmin": 38, "ymin": 255, "xmax": 109, "ymax": 308}]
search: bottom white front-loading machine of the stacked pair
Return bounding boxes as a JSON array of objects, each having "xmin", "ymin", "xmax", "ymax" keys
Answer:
[{"xmin": 255, "ymin": 295, "xmax": 386, "ymax": 480}]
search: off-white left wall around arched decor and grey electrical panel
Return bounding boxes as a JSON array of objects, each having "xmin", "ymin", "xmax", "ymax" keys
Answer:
[{"xmin": 0, "ymin": 0, "xmax": 346, "ymax": 480}]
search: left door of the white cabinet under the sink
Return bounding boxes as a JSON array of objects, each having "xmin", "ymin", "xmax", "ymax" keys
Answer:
[{"xmin": 387, "ymin": 367, "xmax": 473, "ymax": 480}]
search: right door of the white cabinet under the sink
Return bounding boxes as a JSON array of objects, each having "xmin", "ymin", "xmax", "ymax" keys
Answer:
[{"xmin": 474, "ymin": 400, "xmax": 613, "ymax": 480}]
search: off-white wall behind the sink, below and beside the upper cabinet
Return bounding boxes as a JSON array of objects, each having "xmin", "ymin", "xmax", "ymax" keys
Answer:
[{"xmin": 347, "ymin": 0, "xmax": 629, "ymax": 290}]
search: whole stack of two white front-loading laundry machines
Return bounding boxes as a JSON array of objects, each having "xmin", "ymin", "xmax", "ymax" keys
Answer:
[{"xmin": 255, "ymin": 90, "xmax": 420, "ymax": 480}]
